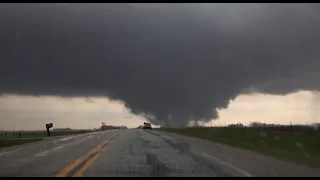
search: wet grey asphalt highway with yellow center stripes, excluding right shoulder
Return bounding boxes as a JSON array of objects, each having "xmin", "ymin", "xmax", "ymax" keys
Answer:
[{"xmin": 0, "ymin": 129, "xmax": 251, "ymax": 177}]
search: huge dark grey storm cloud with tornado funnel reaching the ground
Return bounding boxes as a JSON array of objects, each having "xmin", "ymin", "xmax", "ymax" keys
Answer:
[{"xmin": 0, "ymin": 4, "xmax": 320, "ymax": 126}]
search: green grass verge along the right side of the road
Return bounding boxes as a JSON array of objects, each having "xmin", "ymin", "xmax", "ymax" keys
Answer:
[{"xmin": 158, "ymin": 127, "xmax": 320, "ymax": 168}]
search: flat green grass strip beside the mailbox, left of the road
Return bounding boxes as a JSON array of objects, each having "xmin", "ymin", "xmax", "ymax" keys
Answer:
[{"xmin": 0, "ymin": 130, "xmax": 99, "ymax": 148}]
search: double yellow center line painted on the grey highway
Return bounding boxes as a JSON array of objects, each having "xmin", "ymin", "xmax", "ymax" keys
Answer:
[{"xmin": 56, "ymin": 133, "xmax": 118, "ymax": 177}]
